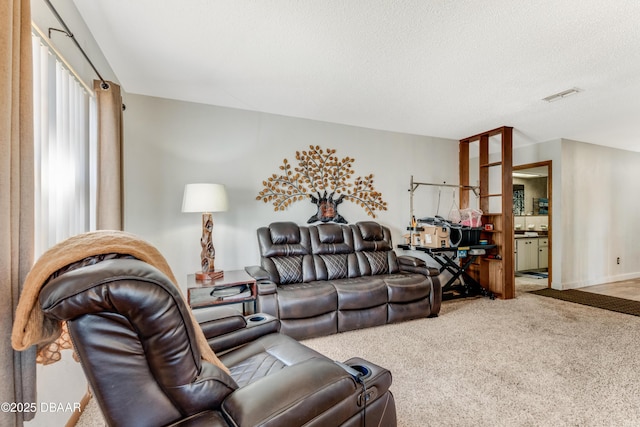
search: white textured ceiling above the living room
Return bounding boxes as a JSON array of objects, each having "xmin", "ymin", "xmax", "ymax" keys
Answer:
[{"xmin": 74, "ymin": 0, "xmax": 640, "ymax": 151}]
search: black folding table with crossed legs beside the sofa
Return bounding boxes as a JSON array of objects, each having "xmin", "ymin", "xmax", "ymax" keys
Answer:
[{"xmin": 398, "ymin": 245, "xmax": 496, "ymax": 300}]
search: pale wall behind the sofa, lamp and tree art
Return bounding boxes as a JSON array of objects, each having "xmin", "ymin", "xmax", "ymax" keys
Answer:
[{"xmin": 124, "ymin": 95, "xmax": 458, "ymax": 286}]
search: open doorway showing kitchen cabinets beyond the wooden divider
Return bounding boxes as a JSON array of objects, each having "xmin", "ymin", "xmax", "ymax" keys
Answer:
[{"xmin": 512, "ymin": 160, "xmax": 553, "ymax": 287}]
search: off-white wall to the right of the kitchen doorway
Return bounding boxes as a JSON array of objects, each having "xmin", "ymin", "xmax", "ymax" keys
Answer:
[{"xmin": 554, "ymin": 140, "xmax": 640, "ymax": 289}]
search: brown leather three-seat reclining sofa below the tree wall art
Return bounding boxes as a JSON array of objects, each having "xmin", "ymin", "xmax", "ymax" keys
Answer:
[{"xmin": 246, "ymin": 221, "xmax": 442, "ymax": 339}]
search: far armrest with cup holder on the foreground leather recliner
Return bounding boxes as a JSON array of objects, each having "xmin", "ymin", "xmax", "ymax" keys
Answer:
[{"xmin": 194, "ymin": 307, "xmax": 280, "ymax": 355}]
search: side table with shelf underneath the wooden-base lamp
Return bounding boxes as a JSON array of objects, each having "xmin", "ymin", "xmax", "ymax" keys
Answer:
[{"xmin": 187, "ymin": 270, "xmax": 257, "ymax": 315}]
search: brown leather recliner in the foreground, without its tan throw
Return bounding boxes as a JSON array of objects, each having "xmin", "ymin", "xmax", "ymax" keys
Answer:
[{"xmin": 39, "ymin": 258, "xmax": 396, "ymax": 427}]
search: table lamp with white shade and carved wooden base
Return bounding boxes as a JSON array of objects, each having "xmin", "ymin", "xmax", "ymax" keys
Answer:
[{"xmin": 182, "ymin": 184, "xmax": 228, "ymax": 280}]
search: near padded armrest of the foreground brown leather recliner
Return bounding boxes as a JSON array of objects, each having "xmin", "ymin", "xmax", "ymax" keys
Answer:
[{"xmin": 222, "ymin": 358, "xmax": 361, "ymax": 426}]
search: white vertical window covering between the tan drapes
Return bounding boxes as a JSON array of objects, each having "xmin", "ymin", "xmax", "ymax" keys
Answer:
[{"xmin": 33, "ymin": 35, "xmax": 96, "ymax": 258}]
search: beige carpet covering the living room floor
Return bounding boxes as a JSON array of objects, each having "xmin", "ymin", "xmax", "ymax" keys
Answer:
[{"xmin": 78, "ymin": 286, "xmax": 640, "ymax": 427}]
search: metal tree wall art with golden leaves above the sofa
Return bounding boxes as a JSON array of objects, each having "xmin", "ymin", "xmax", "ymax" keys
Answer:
[{"xmin": 256, "ymin": 145, "xmax": 387, "ymax": 223}]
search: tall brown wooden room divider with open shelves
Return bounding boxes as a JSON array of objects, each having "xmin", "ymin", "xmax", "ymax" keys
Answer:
[{"xmin": 460, "ymin": 126, "xmax": 515, "ymax": 299}]
